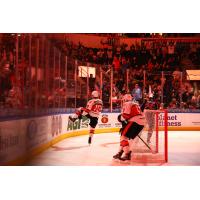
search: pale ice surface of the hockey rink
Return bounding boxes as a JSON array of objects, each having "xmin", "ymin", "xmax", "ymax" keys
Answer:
[{"xmin": 26, "ymin": 131, "xmax": 200, "ymax": 166}]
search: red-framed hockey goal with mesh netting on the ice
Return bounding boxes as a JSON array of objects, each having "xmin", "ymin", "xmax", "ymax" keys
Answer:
[{"xmin": 131, "ymin": 110, "xmax": 168, "ymax": 163}]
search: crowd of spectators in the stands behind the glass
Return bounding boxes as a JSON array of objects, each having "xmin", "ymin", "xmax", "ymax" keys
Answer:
[{"xmin": 0, "ymin": 34, "xmax": 200, "ymax": 111}]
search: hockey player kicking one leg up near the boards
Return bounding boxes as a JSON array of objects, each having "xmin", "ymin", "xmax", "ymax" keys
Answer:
[{"xmin": 69, "ymin": 91, "xmax": 103, "ymax": 144}]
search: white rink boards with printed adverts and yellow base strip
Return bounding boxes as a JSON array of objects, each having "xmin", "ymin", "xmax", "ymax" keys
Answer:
[{"xmin": 0, "ymin": 113, "xmax": 200, "ymax": 165}]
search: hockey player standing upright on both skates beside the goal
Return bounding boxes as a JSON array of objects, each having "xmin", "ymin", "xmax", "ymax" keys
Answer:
[{"xmin": 113, "ymin": 94, "xmax": 145, "ymax": 161}]
